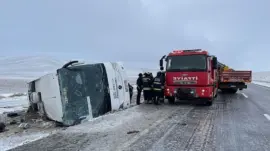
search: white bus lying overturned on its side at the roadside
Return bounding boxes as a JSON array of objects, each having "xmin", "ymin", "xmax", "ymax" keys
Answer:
[{"xmin": 28, "ymin": 61, "xmax": 131, "ymax": 126}]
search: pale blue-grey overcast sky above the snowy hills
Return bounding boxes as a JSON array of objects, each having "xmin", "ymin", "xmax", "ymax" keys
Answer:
[{"xmin": 0, "ymin": 0, "xmax": 270, "ymax": 71}]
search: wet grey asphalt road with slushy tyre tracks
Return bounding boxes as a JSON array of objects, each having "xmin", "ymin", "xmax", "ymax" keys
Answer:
[{"xmin": 9, "ymin": 84, "xmax": 270, "ymax": 151}]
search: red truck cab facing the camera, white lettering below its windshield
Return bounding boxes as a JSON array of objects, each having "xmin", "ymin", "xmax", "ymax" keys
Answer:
[{"xmin": 160, "ymin": 49, "xmax": 218, "ymax": 105}]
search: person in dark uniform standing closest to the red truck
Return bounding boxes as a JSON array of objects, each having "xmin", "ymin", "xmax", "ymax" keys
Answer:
[{"xmin": 153, "ymin": 72, "xmax": 163, "ymax": 105}]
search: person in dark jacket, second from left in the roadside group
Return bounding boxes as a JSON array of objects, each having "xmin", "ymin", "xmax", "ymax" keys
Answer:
[{"xmin": 143, "ymin": 73, "xmax": 152, "ymax": 103}]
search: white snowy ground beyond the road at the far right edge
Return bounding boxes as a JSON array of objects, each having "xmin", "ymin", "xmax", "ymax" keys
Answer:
[{"xmin": 252, "ymin": 71, "xmax": 270, "ymax": 87}]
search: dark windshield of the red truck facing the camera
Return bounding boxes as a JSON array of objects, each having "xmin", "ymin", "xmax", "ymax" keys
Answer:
[{"xmin": 166, "ymin": 55, "xmax": 207, "ymax": 71}]
